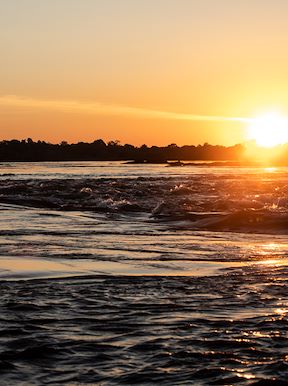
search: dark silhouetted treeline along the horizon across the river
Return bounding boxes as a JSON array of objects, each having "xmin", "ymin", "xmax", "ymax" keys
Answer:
[{"xmin": 0, "ymin": 138, "xmax": 288, "ymax": 166}]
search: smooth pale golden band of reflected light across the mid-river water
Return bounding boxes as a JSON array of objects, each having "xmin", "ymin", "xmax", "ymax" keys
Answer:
[{"xmin": 0, "ymin": 256, "xmax": 249, "ymax": 280}]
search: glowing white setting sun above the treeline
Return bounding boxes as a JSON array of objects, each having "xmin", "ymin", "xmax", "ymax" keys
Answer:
[{"xmin": 248, "ymin": 113, "xmax": 288, "ymax": 147}]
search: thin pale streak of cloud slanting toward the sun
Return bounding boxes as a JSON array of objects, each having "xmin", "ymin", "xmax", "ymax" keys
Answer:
[{"xmin": 0, "ymin": 95, "xmax": 249, "ymax": 122}]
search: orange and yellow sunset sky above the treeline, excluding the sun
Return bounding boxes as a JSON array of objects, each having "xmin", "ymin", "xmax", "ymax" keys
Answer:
[{"xmin": 0, "ymin": 0, "xmax": 288, "ymax": 145}]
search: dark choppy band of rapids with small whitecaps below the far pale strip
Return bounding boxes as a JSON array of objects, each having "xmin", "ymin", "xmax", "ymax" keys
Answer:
[{"xmin": 0, "ymin": 174, "xmax": 288, "ymax": 233}]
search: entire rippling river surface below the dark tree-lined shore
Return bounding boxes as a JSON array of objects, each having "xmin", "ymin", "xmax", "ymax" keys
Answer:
[{"xmin": 0, "ymin": 162, "xmax": 288, "ymax": 385}]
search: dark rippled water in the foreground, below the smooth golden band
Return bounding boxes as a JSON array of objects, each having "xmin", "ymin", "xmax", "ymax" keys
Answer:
[{"xmin": 0, "ymin": 265, "xmax": 288, "ymax": 386}]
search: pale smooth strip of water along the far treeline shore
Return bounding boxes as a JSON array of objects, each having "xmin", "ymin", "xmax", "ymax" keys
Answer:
[{"xmin": 0, "ymin": 161, "xmax": 287, "ymax": 178}]
